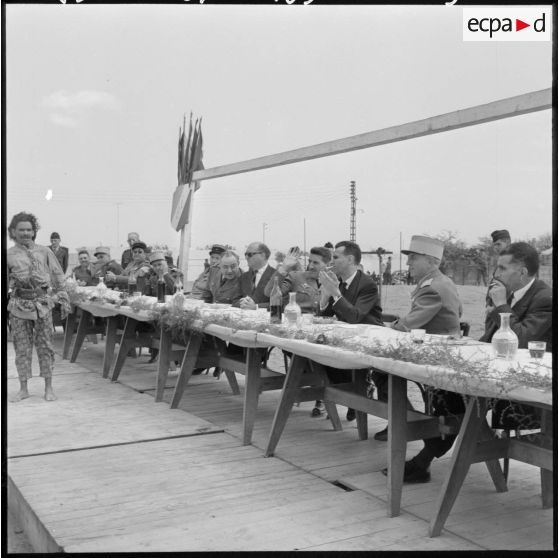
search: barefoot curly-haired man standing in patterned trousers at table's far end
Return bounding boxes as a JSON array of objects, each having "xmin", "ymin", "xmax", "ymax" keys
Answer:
[{"xmin": 7, "ymin": 212, "xmax": 70, "ymax": 401}]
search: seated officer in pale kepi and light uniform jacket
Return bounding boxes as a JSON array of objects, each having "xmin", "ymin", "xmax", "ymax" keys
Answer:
[{"xmin": 380, "ymin": 235, "xmax": 465, "ymax": 482}]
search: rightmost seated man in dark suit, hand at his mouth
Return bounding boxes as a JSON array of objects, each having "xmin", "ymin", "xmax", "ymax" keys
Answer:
[{"xmin": 480, "ymin": 242, "xmax": 552, "ymax": 429}]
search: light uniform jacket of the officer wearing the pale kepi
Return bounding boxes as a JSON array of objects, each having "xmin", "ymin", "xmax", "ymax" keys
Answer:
[{"xmin": 393, "ymin": 269, "xmax": 462, "ymax": 335}]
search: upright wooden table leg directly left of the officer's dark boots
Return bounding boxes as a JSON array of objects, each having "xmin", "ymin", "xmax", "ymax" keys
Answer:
[{"xmin": 387, "ymin": 374, "xmax": 407, "ymax": 517}]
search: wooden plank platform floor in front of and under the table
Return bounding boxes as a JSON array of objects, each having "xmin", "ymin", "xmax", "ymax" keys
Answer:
[{"xmin": 8, "ymin": 336, "xmax": 552, "ymax": 552}]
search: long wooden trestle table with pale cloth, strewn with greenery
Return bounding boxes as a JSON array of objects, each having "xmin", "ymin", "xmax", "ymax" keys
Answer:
[{"xmin": 64, "ymin": 294, "xmax": 553, "ymax": 536}]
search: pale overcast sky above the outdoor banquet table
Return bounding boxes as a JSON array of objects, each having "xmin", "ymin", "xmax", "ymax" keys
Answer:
[{"xmin": 6, "ymin": 3, "xmax": 552, "ymax": 268}]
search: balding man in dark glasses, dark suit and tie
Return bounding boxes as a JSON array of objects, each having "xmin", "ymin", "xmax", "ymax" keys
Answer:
[{"xmin": 235, "ymin": 242, "xmax": 276, "ymax": 310}]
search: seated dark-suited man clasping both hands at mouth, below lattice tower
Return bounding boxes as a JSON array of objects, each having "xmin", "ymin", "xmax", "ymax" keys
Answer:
[{"xmin": 319, "ymin": 240, "xmax": 383, "ymax": 421}]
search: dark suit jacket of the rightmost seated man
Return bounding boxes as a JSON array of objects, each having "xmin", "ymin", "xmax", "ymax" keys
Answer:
[{"xmin": 480, "ymin": 279, "xmax": 552, "ymax": 351}]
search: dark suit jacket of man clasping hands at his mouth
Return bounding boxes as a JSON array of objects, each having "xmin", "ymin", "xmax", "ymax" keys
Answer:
[{"xmin": 322, "ymin": 270, "xmax": 384, "ymax": 325}]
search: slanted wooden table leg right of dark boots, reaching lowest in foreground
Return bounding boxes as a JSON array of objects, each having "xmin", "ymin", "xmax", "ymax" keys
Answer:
[{"xmin": 428, "ymin": 397, "xmax": 486, "ymax": 537}]
